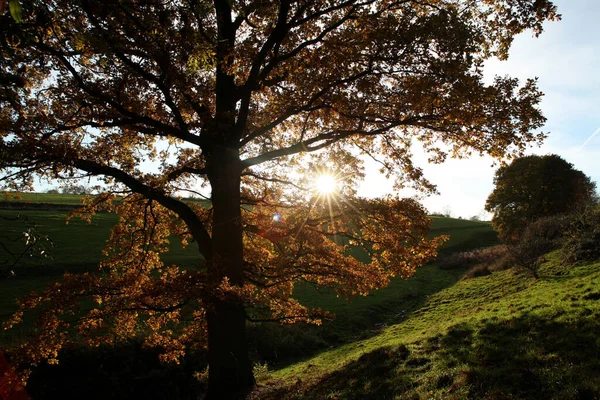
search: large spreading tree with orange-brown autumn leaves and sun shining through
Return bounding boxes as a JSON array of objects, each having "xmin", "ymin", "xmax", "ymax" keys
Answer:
[{"xmin": 0, "ymin": 0, "xmax": 559, "ymax": 398}]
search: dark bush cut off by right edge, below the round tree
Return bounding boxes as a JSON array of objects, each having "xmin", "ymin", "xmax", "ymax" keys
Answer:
[{"xmin": 562, "ymin": 205, "xmax": 600, "ymax": 264}]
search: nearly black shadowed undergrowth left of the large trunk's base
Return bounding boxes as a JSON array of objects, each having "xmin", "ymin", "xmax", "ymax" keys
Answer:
[{"xmin": 27, "ymin": 343, "xmax": 206, "ymax": 400}]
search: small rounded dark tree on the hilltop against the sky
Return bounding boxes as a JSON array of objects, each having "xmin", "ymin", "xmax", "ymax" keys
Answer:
[{"xmin": 485, "ymin": 154, "xmax": 596, "ymax": 242}]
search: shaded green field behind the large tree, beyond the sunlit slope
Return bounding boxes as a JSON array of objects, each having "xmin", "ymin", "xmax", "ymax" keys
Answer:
[{"xmin": 0, "ymin": 194, "xmax": 497, "ymax": 350}]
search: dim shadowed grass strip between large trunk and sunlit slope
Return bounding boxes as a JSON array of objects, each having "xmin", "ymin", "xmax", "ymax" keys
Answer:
[{"xmin": 248, "ymin": 265, "xmax": 465, "ymax": 368}]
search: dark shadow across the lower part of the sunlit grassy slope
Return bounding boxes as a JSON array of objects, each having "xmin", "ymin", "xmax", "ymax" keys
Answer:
[{"xmin": 257, "ymin": 310, "xmax": 600, "ymax": 400}]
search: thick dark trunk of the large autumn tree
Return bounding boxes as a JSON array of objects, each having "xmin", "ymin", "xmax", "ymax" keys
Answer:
[{"xmin": 206, "ymin": 147, "xmax": 255, "ymax": 400}]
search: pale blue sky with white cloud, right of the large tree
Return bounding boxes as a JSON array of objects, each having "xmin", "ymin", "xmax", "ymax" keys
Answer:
[{"xmin": 361, "ymin": 0, "xmax": 600, "ymax": 219}]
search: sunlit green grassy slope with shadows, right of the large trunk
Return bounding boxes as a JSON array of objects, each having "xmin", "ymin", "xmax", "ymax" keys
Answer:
[{"xmin": 256, "ymin": 254, "xmax": 600, "ymax": 399}]
